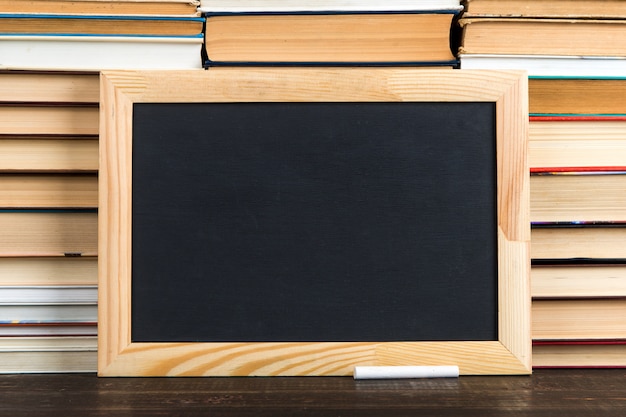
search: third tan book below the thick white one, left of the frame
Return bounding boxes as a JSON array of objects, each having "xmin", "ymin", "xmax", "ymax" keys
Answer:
[{"xmin": 0, "ymin": 136, "xmax": 98, "ymax": 172}]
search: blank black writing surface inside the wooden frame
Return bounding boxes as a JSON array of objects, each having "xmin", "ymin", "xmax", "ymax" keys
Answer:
[{"xmin": 131, "ymin": 102, "xmax": 498, "ymax": 342}]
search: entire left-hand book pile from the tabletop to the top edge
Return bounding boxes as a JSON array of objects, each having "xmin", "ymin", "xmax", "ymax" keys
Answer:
[{"xmin": 0, "ymin": 0, "xmax": 204, "ymax": 372}]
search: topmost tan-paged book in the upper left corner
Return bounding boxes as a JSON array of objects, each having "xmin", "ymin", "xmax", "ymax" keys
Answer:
[{"xmin": 0, "ymin": 0, "xmax": 200, "ymax": 16}]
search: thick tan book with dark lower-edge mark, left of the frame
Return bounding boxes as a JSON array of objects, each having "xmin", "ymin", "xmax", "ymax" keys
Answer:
[{"xmin": 0, "ymin": 210, "xmax": 98, "ymax": 257}]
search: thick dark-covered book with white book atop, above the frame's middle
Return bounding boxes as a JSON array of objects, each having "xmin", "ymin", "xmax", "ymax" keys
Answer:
[{"xmin": 200, "ymin": 0, "xmax": 462, "ymax": 68}]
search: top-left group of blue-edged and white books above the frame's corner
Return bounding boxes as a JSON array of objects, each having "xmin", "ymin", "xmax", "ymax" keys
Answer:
[{"xmin": 0, "ymin": 0, "xmax": 204, "ymax": 71}]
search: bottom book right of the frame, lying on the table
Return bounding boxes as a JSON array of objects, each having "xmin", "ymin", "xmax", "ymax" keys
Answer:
[{"xmin": 533, "ymin": 339, "xmax": 626, "ymax": 368}]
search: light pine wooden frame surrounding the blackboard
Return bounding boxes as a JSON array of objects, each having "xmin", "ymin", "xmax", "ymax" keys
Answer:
[{"xmin": 98, "ymin": 68, "xmax": 531, "ymax": 376}]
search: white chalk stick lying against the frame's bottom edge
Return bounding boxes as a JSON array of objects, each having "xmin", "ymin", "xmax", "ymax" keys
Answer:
[{"xmin": 354, "ymin": 365, "xmax": 459, "ymax": 379}]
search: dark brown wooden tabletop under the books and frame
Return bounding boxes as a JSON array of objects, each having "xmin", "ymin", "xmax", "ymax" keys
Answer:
[{"xmin": 0, "ymin": 369, "xmax": 626, "ymax": 417}]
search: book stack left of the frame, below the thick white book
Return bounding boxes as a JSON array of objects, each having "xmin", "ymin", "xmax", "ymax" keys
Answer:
[{"xmin": 0, "ymin": 71, "xmax": 99, "ymax": 372}]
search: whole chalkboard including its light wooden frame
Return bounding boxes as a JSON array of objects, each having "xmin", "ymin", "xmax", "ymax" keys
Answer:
[{"xmin": 99, "ymin": 69, "xmax": 530, "ymax": 375}]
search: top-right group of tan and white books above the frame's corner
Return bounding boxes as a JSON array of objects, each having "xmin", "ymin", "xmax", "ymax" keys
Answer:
[{"xmin": 459, "ymin": 0, "xmax": 626, "ymax": 76}]
